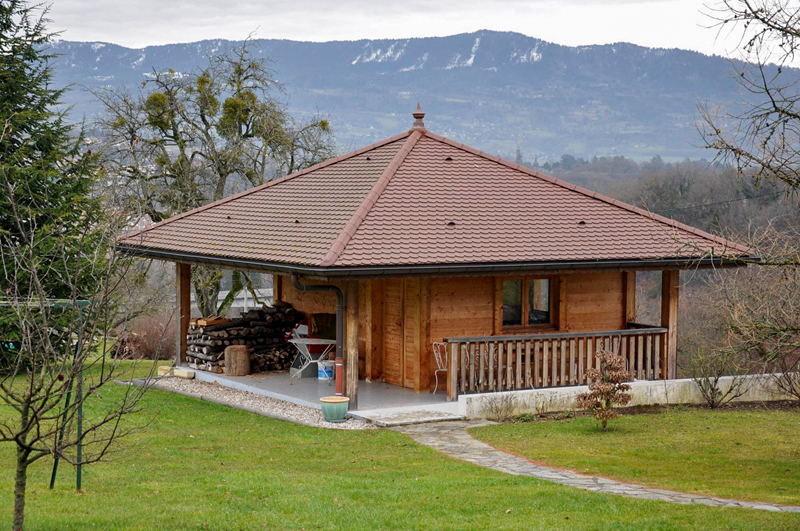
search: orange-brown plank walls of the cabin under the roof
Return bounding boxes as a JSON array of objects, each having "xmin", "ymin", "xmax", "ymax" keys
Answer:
[{"xmin": 275, "ymin": 273, "xmax": 630, "ymax": 392}]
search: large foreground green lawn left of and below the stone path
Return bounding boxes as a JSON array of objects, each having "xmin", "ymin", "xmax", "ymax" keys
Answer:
[{"xmin": 0, "ymin": 380, "xmax": 800, "ymax": 530}]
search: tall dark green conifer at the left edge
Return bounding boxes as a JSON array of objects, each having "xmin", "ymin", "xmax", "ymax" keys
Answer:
[{"xmin": 0, "ymin": 0, "xmax": 102, "ymax": 310}]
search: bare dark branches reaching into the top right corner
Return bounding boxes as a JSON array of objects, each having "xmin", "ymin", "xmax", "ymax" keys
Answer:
[{"xmin": 700, "ymin": 0, "xmax": 800, "ymax": 196}]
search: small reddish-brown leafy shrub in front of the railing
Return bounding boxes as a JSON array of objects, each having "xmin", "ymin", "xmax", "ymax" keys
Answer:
[{"xmin": 578, "ymin": 350, "xmax": 631, "ymax": 431}]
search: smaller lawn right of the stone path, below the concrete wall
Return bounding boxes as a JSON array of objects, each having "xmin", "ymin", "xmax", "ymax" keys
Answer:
[{"xmin": 471, "ymin": 409, "xmax": 800, "ymax": 505}]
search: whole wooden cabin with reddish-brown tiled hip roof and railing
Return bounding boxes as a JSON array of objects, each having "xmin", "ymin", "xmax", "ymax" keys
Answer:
[{"xmin": 118, "ymin": 107, "xmax": 751, "ymax": 406}]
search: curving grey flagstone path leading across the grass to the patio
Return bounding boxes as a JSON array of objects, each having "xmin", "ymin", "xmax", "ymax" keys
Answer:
[{"xmin": 392, "ymin": 421, "xmax": 800, "ymax": 513}]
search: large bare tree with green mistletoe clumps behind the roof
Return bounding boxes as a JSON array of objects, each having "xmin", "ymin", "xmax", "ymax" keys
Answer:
[{"xmin": 95, "ymin": 40, "xmax": 334, "ymax": 315}]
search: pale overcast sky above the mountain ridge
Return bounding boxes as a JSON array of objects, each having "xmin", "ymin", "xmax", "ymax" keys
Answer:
[{"xmin": 51, "ymin": 0, "xmax": 748, "ymax": 55}]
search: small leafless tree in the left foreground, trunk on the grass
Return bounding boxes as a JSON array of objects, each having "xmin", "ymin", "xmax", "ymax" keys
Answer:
[{"xmin": 0, "ymin": 148, "xmax": 161, "ymax": 529}]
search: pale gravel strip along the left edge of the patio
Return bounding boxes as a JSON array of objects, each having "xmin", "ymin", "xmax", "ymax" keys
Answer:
[{"xmin": 133, "ymin": 376, "xmax": 376, "ymax": 430}]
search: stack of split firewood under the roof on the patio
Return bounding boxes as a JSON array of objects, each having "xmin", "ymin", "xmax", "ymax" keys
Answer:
[{"xmin": 186, "ymin": 307, "xmax": 298, "ymax": 373}]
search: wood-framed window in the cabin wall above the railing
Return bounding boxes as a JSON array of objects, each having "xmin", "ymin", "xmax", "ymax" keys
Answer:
[{"xmin": 503, "ymin": 278, "xmax": 550, "ymax": 327}]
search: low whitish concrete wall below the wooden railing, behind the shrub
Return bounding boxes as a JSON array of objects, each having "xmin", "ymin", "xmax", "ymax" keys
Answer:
[{"xmin": 458, "ymin": 375, "xmax": 790, "ymax": 419}]
